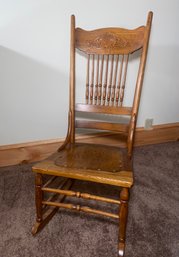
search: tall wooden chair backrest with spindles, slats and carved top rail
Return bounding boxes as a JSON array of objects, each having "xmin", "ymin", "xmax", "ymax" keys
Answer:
[{"xmin": 67, "ymin": 12, "xmax": 152, "ymax": 156}]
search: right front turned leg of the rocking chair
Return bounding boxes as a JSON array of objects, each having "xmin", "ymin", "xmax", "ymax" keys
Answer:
[{"xmin": 118, "ymin": 188, "xmax": 129, "ymax": 256}]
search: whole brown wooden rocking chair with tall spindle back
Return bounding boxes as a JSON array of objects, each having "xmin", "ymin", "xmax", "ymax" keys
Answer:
[{"xmin": 32, "ymin": 12, "xmax": 152, "ymax": 256}]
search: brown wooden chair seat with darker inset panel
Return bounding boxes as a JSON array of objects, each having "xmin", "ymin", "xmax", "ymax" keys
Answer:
[{"xmin": 32, "ymin": 143, "xmax": 133, "ymax": 187}]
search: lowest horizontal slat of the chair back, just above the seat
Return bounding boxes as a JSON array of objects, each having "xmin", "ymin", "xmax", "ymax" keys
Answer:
[{"xmin": 75, "ymin": 120, "xmax": 129, "ymax": 133}]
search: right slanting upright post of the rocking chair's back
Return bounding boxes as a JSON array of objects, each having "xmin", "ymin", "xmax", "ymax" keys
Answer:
[{"xmin": 127, "ymin": 11, "xmax": 153, "ymax": 157}]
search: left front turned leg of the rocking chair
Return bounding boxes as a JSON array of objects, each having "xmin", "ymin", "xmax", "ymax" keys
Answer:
[{"xmin": 35, "ymin": 173, "xmax": 43, "ymax": 222}]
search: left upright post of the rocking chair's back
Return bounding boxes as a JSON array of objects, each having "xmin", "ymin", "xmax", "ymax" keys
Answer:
[{"xmin": 68, "ymin": 15, "xmax": 75, "ymax": 143}]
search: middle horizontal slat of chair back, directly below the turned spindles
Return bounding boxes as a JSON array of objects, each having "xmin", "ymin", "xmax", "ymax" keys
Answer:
[{"xmin": 75, "ymin": 104, "xmax": 132, "ymax": 115}]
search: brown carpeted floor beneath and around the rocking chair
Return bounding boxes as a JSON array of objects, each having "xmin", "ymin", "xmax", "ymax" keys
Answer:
[{"xmin": 0, "ymin": 142, "xmax": 179, "ymax": 257}]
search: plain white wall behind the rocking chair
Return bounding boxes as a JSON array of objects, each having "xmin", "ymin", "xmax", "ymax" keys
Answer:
[{"xmin": 0, "ymin": 0, "xmax": 179, "ymax": 145}]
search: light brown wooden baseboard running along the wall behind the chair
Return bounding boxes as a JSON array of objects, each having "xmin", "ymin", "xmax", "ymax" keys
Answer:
[{"xmin": 0, "ymin": 122, "xmax": 179, "ymax": 167}]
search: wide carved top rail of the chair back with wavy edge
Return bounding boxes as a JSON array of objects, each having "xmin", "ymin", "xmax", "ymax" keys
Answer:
[{"xmin": 75, "ymin": 26, "xmax": 145, "ymax": 54}]
